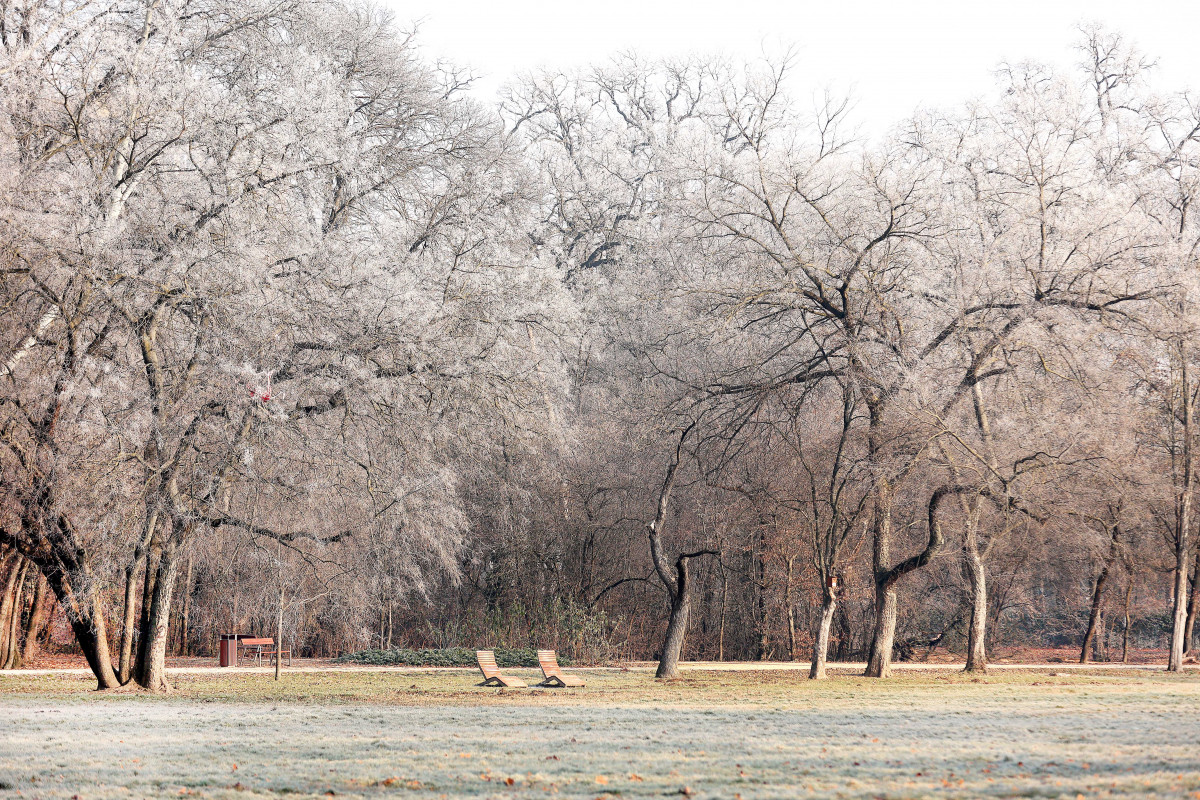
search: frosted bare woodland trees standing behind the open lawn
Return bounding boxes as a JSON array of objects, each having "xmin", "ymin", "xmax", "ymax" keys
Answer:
[{"xmin": 0, "ymin": 0, "xmax": 1200, "ymax": 688}]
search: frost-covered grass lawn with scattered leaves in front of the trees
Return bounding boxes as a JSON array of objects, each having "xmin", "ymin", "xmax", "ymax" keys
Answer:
[{"xmin": 0, "ymin": 672, "xmax": 1200, "ymax": 800}]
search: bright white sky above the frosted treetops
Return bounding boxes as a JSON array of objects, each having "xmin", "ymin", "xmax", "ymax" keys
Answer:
[{"xmin": 384, "ymin": 0, "xmax": 1200, "ymax": 132}]
